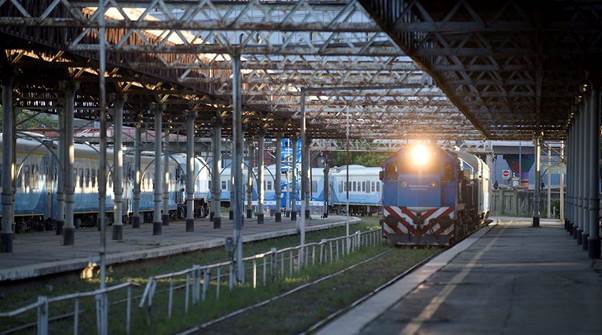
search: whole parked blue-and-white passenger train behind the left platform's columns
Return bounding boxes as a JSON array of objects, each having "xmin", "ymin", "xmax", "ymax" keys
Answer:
[{"xmin": 0, "ymin": 136, "xmax": 390, "ymax": 232}]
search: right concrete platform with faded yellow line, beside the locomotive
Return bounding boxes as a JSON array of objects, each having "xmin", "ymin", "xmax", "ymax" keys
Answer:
[{"xmin": 321, "ymin": 218, "xmax": 602, "ymax": 334}]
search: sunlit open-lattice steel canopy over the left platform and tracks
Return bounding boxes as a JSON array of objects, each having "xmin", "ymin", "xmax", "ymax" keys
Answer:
[{"xmin": 0, "ymin": 0, "xmax": 484, "ymax": 140}]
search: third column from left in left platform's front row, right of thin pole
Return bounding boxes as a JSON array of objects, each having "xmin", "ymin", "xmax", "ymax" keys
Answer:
[{"xmin": 113, "ymin": 97, "xmax": 125, "ymax": 241}]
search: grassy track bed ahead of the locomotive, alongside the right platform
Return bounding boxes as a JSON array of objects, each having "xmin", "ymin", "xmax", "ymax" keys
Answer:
[{"xmin": 197, "ymin": 247, "xmax": 440, "ymax": 334}]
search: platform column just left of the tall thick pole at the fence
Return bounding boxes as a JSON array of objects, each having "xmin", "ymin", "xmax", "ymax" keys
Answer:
[{"xmin": 211, "ymin": 114, "xmax": 222, "ymax": 229}]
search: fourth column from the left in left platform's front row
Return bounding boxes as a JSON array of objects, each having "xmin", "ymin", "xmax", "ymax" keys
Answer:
[{"xmin": 152, "ymin": 104, "xmax": 165, "ymax": 235}]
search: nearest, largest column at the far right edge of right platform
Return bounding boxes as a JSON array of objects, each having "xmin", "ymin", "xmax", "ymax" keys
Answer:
[{"xmin": 584, "ymin": 83, "xmax": 600, "ymax": 258}]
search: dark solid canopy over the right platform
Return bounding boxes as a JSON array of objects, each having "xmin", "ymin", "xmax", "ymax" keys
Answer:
[{"xmin": 360, "ymin": 0, "xmax": 602, "ymax": 139}]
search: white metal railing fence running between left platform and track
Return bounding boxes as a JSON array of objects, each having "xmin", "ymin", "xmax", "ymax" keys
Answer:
[{"xmin": 0, "ymin": 229, "xmax": 383, "ymax": 335}]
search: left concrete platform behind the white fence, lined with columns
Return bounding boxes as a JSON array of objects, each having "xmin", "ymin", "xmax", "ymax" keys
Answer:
[{"xmin": 0, "ymin": 216, "xmax": 360, "ymax": 282}]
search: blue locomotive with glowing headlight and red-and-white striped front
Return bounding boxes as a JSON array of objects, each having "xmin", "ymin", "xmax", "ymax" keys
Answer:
[{"xmin": 382, "ymin": 144, "xmax": 490, "ymax": 245}]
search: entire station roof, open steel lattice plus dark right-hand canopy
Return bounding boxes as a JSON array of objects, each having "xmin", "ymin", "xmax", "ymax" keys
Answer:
[{"xmin": 0, "ymin": 0, "xmax": 602, "ymax": 140}]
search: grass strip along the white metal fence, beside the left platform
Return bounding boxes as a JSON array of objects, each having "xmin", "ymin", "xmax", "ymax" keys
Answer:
[{"xmin": 0, "ymin": 218, "xmax": 378, "ymax": 333}]
